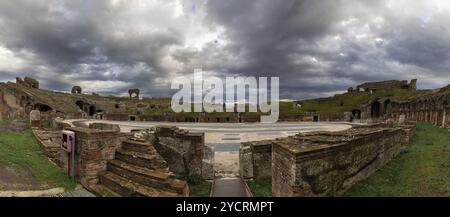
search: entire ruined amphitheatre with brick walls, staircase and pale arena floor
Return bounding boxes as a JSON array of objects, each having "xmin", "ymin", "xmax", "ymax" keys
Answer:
[{"xmin": 0, "ymin": 77, "xmax": 450, "ymax": 196}]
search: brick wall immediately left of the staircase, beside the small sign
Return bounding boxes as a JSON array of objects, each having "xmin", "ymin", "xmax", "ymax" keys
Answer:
[{"xmin": 60, "ymin": 127, "xmax": 126, "ymax": 187}]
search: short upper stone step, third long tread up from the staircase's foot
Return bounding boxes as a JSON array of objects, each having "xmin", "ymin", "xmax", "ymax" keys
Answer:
[{"xmin": 115, "ymin": 149, "xmax": 167, "ymax": 169}]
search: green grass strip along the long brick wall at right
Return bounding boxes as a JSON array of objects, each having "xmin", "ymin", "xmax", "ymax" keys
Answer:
[{"xmin": 346, "ymin": 123, "xmax": 450, "ymax": 196}]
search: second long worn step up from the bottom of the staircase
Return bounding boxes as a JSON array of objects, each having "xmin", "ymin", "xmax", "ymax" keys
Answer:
[{"xmin": 107, "ymin": 159, "xmax": 189, "ymax": 196}]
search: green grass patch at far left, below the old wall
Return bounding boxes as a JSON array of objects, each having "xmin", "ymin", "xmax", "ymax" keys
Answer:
[{"xmin": 0, "ymin": 130, "xmax": 75, "ymax": 190}]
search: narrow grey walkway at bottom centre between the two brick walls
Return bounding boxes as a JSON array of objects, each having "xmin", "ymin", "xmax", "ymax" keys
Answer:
[{"xmin": 212, "ymin": 178, "xmax": 249, "ymax": 197}]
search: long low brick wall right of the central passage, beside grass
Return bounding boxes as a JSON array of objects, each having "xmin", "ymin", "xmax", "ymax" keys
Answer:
[{"xmin": 272, "ymin": 125, "xmax": 415, "ymax": 196}]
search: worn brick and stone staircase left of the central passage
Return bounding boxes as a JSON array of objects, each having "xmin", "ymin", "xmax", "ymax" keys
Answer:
[{"xmin": 91, "ymin": 140, "xmax": 189, "ymax": 197}]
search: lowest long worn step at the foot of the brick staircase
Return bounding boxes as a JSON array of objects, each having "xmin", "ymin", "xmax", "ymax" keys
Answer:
[{"xmin": 99, "ymin": 171, "xmax": 179, "ymax": 197}]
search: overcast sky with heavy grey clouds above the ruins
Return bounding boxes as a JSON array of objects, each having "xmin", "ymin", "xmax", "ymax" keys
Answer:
[{"xmin": 0, "ymin": 0, "xmax": 450, "ymax": 99}]
